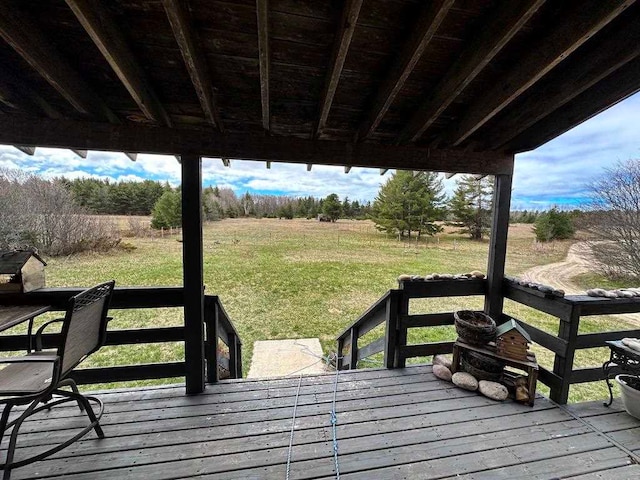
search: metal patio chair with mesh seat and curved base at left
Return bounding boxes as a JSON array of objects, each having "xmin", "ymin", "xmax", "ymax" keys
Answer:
[{"xmin": 0, "ymin": 281, "xmax": 115, "ymax": 480}]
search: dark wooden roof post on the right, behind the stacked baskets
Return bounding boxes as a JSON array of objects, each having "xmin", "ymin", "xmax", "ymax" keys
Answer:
[{"xmin": 484, "ymin": 169, "xmax": 512, "ymax": 320}]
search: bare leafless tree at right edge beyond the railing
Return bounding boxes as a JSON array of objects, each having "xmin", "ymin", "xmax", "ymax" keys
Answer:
[{"xmin": 588, "ymin": 159, "xmax": 640, "ymax": 277}]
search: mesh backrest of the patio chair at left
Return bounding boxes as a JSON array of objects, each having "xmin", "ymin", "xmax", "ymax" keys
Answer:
[{"xmin": 58, "ymin": 281, "xmax": 115, "ymax": 378}]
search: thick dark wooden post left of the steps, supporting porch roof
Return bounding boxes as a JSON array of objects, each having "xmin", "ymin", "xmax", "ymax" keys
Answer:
[{"xmin": 182, "ymin": 155, "xmax": 204, "ymax": 393}]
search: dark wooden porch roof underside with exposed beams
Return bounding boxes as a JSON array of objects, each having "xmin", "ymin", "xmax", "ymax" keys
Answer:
[{"xmin": 0, "ymin": 0, "xmax": 640, "ymax": 173}]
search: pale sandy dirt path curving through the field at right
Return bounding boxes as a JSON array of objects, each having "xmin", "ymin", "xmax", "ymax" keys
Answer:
[{"xmin": 522, "ymin": 242, "xmax": 640, "ymax": 326}]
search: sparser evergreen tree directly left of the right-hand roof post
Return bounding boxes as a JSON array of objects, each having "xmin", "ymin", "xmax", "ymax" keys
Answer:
[{"xmin": 449, "ymin": 175, "xmax": 493, "ymax": 240}]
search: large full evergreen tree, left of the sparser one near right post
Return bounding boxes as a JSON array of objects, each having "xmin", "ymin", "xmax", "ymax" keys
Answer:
[{"xmin": 371, "ymin": 171, "xmax": 444, "ymax": 239}]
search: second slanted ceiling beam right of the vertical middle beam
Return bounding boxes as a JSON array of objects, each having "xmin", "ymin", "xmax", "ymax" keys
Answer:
[{"xmin": 358, "ymin": 0, "xmax": 454, "ymax": 140}]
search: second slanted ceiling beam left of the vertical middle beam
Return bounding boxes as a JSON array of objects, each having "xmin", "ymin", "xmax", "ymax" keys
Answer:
[{"xmin": 66, "ymin": 0, "xmax": 171, "ymax": 126}]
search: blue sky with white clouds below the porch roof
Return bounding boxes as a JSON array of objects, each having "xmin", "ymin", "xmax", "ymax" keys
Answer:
[{"xmin": 0, "ymin": 93, "xmax": 640, "ymax": 209}]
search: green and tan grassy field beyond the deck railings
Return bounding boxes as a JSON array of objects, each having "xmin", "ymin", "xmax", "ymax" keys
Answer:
[{"xmin": 17, "ymin": 219, "xmax": 636, "ymax": 401}]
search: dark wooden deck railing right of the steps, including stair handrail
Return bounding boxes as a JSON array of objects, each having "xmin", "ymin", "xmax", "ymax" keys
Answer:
[{"xmin": 337, "ymin": 279, "xmax": 640, "ymax": 403}]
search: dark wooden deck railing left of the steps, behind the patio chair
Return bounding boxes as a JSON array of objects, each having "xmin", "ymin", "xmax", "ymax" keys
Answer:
[{"xmin": 0, "ymin": 287, "xmax": 242, "ymax": 384}]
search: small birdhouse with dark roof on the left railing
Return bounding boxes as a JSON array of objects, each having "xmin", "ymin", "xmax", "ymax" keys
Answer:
[{"xmin": 0, "ymin": 250, "xmax": 46, "ymax": 293}]
